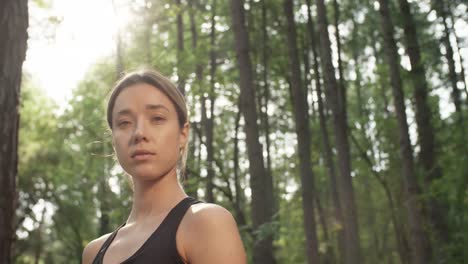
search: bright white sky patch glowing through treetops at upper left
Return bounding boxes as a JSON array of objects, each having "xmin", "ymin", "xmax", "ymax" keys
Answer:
[{"xmin": 24, "ymin": 0, "xmax": 129, "ymax": 103}]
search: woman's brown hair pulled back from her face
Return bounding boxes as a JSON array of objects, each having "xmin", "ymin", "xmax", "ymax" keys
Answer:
[{"xmin": 107, "ymin": 70, "xmax": 188, "ymax": 177}]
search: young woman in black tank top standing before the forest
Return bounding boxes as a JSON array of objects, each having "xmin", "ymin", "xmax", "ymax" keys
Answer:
[{"xmin": 83, "ymin": 71, "xmax": 246, "ymax": 264}]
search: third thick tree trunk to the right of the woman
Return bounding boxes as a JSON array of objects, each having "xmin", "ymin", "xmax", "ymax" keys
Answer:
[{"xmin": 316, "ymin": 0, "xmax": 361, "ymax": 264}]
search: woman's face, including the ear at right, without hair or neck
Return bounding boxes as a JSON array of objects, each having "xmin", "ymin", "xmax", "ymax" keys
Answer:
[{"xmin": 112, "ymin": 83, "xmax": 188, "ymax": 180}]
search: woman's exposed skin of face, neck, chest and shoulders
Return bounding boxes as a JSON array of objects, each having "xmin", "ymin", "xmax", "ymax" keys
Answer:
[{"xmin": 82, "ymin": 84, "xmax": 246, "ymax": 264}]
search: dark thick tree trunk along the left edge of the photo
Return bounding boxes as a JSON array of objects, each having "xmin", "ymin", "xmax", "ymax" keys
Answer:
[{"xmin": 0, "ymin": 0, "xmax": 28, "ymax": 263}]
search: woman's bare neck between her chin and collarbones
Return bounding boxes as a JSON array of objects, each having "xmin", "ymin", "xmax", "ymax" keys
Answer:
[{"xmin": 127, "ymin": 168, "xmax": 187, "ymax": 224}]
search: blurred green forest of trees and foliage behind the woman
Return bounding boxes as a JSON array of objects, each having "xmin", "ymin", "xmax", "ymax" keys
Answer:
[{"xmin": 0, "ymin": 0, "xmax": 468, "ymax": 264}]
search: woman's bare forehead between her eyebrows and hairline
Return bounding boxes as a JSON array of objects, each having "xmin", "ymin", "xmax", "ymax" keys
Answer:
[{"xmin": 112, "ymin": 83, "xmax": 176, "ymax": 114}]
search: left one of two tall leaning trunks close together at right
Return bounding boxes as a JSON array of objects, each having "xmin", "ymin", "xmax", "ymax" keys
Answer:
[{"xmin": 379, "ymin": 0, "xmax": 431, "ymax": 264}]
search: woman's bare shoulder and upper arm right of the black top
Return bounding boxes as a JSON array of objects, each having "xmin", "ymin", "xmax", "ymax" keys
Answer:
[{"xmin": 180, "ymin": 203, "xmax": 247, "ymax": 264}]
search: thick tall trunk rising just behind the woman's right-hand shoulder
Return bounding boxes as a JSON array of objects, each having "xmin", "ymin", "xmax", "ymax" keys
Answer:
[{"xmin": 230, "ymin": 0, "xmax": 275, "ymax": 264}]
